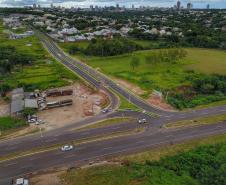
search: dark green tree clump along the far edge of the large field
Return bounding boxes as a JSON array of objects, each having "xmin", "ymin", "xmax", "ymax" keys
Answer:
[{"xmin": 84, "ymin": 38, "xmax": 142, "ymax": 56}]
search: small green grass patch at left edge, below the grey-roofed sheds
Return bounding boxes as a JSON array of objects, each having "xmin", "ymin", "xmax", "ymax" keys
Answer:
[{"xmin": 0, "ymin": 116, "xmax": 27, "ymax": 131}]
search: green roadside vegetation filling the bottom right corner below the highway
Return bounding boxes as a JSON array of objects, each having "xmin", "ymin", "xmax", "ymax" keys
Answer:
[{"xmin": 62, "ymin": 143, "xmax": 226, "ymax": 185}]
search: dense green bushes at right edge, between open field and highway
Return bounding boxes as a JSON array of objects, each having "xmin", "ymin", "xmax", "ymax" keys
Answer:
[{"xmin": 168, "ymin": 74, "xmax": 226, "ymax": 109}]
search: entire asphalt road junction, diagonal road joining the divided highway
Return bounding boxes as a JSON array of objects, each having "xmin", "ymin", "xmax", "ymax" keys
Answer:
[{"xmin": 0, "ymin": 31, "xmax": 226, "ymax": 185}]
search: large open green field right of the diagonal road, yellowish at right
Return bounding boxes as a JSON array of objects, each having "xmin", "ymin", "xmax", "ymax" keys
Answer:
[{"xmin": 61, "ymin": 48, "xmax": 226, "ymax": 94}]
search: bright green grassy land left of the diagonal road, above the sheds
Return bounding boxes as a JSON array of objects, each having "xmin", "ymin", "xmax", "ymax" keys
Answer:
[{"xmin": 0, "ymin": 19, "xmax": 78, "ymax": 90}]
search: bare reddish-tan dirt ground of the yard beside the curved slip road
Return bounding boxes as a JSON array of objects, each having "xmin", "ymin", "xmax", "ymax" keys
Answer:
[{"xmin": 37, "ymin": 83, "xmax": 108, "ymax": 130}]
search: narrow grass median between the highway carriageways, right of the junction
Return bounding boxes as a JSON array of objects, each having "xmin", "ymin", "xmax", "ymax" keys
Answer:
[{"xmin": 165, "ymin": 114, "xmax": 226, "ymax": 128}]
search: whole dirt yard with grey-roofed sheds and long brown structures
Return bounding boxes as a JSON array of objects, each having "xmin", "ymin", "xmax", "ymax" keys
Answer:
[{"xmin": 7, "ymin": 83, "xmax": 109, "ymax": 130}]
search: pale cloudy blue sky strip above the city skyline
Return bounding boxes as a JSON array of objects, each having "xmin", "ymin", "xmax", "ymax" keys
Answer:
[{"xmin": 0, "ymin": 0, "xmax": 226, "ymax": 9}]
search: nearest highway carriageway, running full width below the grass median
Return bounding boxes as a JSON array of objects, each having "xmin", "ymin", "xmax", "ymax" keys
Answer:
[{"xmin": 0, "ymin": 122, "xmax": 226, "ymax": 185}]
